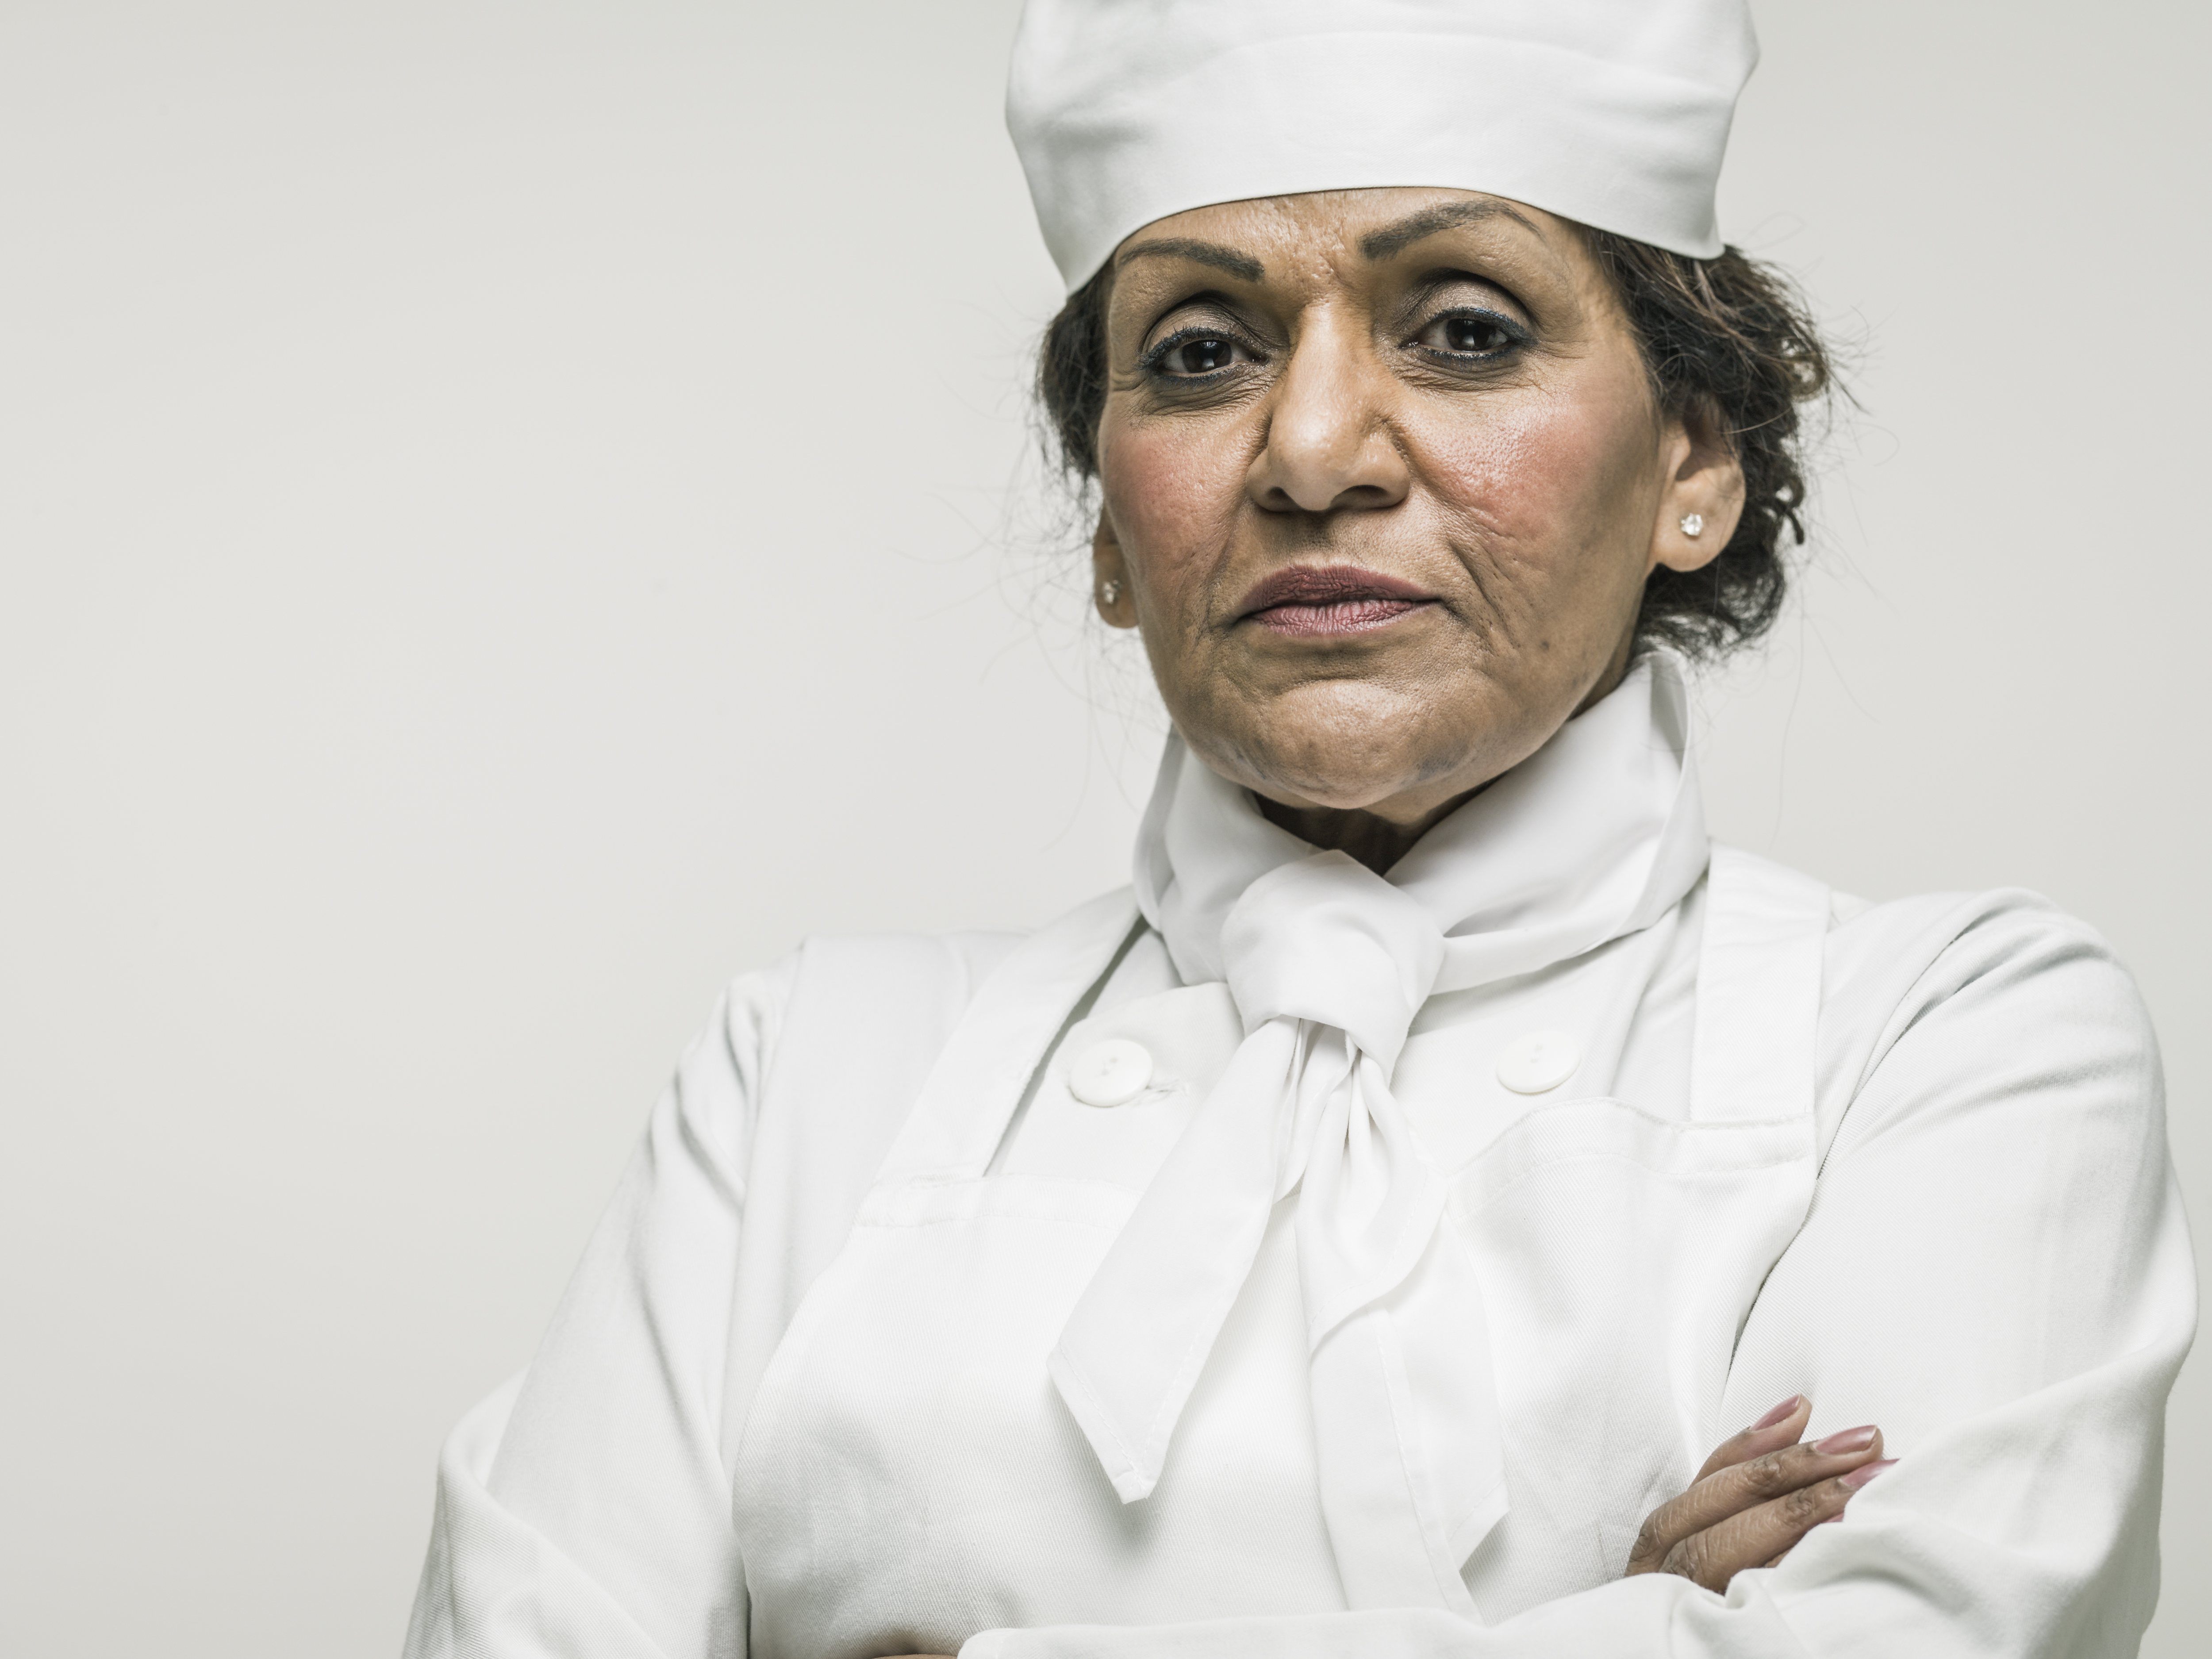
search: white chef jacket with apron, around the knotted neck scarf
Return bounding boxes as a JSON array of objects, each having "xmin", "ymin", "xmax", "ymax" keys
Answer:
[{"xmin": 407, "ymin": 832, "xmax": 2194, "ymax": 1659}]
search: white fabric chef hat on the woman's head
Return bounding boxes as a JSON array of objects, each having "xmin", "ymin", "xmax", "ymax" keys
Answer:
[{"xmin": 1006, "ymin": 0, "xmax": 1759, "ymax": 292}]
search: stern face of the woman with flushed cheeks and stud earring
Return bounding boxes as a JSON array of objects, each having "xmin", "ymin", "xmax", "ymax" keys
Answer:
[{"xmin": 1095, "ymin": 190, "xmax": 1743, "ymax": 845}]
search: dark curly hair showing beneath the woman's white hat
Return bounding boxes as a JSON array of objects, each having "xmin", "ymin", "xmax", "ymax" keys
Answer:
[{"xmin": 1037, "ymin": 228, "xmax": 1834, "ymax": 657}]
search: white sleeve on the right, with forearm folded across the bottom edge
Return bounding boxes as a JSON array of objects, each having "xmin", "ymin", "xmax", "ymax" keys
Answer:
[{"xmin": 962, "ymin": 896, "xmax": 2197, "ymax": 1659}]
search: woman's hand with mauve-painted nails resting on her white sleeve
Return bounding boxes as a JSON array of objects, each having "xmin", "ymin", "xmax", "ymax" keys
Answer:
[{"xmin": 1624, "ymin": 1394, "xmax": 1896, "ymax": 1590}]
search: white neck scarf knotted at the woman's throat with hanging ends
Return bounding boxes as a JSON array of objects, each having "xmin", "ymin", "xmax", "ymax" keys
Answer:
[{"xmin": 1051, "ymin": 653, "xmax": 1705, "ymax": 1610}]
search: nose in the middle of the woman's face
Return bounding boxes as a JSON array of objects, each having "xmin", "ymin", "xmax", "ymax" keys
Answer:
[{"xmin": 1245, "ymin": 316, "xmax": 1411, "ymax": 513}]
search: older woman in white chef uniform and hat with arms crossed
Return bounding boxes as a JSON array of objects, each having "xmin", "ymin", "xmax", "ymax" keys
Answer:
[{"xmin": 409, "ymin": 0, "xmax": 2194, "ymax": 1659}]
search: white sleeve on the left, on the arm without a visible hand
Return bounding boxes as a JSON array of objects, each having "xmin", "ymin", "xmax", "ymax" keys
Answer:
[{"xmin": 405, "ymin": 964, "xmax": 792, "ymax": 1659}]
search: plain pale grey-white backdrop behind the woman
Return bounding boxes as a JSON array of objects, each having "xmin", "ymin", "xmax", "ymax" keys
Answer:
[{"xmin": 0, "ymin": 0, "xmax": 2212, "ymax": 1659}]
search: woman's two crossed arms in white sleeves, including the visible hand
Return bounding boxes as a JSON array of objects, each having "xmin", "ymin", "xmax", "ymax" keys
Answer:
[{"xmin": 409, "ymin": 900, "xmax": 2197, "ymax": 1659}]
